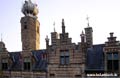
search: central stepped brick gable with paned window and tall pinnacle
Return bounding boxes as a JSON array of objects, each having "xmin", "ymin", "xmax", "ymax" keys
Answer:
[{"xmin": 47, "ymin": 19, "xmax": 86, "ymax": 78}]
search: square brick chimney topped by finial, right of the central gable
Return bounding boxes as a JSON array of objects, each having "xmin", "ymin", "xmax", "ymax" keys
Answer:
[{"xmin": 85, "ymin": 17, "xmax": 93, "ymax": 47}]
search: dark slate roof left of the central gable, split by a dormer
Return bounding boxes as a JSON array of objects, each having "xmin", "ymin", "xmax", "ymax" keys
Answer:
[{"xmin": 9, "ymin": 50, "xmax": 47, "ymax": 71}]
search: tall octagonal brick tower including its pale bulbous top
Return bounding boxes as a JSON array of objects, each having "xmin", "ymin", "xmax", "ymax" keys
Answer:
[{"xmin": 21, "ymin": 0, "xmax": 40, "ymax": 50}]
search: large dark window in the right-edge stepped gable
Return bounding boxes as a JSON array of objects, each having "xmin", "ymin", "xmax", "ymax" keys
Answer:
[{"xmin": 107, "ymin": 52, "xmax": 119, "ymax": 71}]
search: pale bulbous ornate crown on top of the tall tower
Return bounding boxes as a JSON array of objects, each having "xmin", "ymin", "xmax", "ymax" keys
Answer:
[{"xmin": 22, "ymin": 0, "xmax": 38, "ymax": 16}]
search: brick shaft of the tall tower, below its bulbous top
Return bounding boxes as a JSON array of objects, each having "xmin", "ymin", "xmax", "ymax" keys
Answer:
[{"xmin": 21, "ymin": 16, "xmax": 40, "ymax": 50}]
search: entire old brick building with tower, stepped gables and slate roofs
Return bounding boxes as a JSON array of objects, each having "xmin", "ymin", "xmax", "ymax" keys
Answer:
[{"xmin": 0, "ymin": 0, "xmax": 120, "ymax": 78}]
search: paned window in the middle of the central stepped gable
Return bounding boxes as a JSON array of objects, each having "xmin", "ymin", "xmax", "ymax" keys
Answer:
[{"xmin": 60, "ymin": 50, "xmax": 69, "ymax": 65}]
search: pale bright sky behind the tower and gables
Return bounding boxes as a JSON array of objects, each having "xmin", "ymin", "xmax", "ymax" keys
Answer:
[{"xmin": 0, "ymin": 0, "xmax": 120, "ymax": 51}]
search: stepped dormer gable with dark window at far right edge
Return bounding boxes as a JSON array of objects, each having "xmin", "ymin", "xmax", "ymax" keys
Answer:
[{"xmin": 104, "ymin": 32, "xmax": 120, "ymax": 75}]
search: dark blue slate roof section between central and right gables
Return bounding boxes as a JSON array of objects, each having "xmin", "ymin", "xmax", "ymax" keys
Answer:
[{"xmin": 86, "ymin": 44, "xmax": 104, "ymax": 71}]
